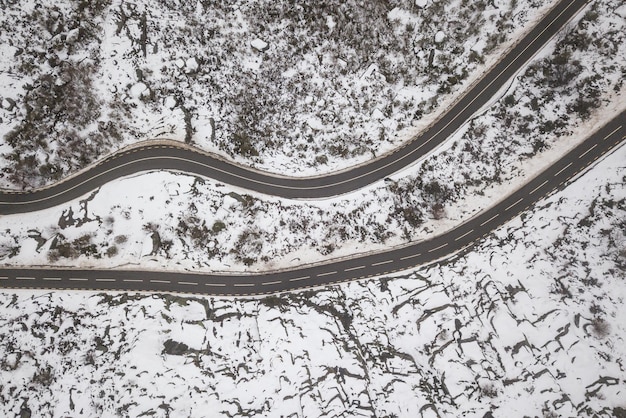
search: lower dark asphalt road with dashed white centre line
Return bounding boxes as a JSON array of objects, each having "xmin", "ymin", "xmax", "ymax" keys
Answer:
[{"xmin": 0, "ymin": 112, "xmax": 626, "ymax": 296}]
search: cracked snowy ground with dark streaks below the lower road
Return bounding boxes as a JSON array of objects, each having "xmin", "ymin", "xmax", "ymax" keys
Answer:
[{"xmin": 0, "ymin": 138, "xmax": 626, "ymax": 418}]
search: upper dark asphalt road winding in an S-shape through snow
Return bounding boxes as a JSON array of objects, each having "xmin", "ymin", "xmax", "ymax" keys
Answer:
[{"xmin": 0, "ymin": 0, "xmax": 588, "ymax": 215}]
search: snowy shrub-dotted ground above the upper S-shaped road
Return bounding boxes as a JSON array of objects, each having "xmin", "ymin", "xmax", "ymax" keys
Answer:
[{"xmin": 0, "ymin": 0, "xmax": 555, "ymax": 188}]
